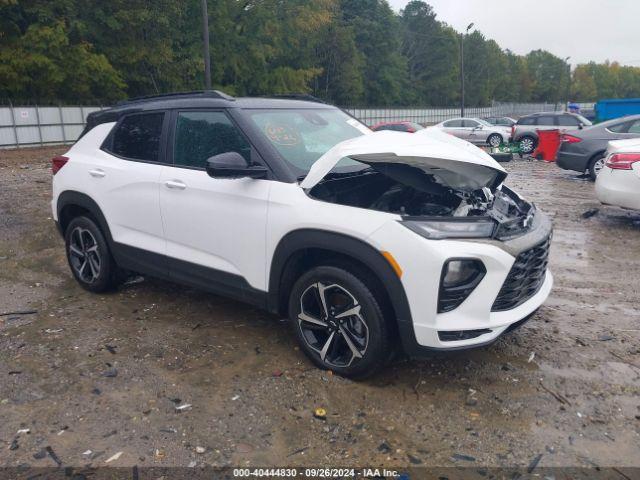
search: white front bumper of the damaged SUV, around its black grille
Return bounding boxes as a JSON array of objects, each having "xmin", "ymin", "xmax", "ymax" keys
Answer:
[{"xmin": 371, "ymin": 212, "xmax": 553, "ymax": 356}]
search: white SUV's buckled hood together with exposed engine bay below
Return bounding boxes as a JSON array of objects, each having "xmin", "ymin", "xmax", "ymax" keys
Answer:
[{"xmin": 301, "ymin": 129, "xmax": 536, "ymax": 240}]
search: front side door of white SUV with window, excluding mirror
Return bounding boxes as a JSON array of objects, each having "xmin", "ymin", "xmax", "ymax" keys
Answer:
[{"xmin": 160, "ymin": 110, "xmax": 272, "ymax": 301}]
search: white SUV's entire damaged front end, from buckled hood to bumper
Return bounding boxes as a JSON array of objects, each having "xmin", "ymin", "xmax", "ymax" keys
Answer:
[{"xmin": 300, "ymin": 129, "xmax": 553, "ymax": 355}]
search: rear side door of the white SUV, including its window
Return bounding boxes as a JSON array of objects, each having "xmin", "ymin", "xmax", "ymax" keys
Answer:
[{"xmin": 97, "ymin": 111, "xmax": 168, "ymax": 273}]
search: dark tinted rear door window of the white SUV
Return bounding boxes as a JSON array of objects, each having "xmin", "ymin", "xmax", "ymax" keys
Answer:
[{"xmin": 111, "ymin": 112, "xmax": 164, "ymax": 162}]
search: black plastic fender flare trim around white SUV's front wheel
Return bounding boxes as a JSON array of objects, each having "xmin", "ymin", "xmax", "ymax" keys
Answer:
[{"xmin": 267, "ymin": 229, "xmax": 420, "ymax": 354}]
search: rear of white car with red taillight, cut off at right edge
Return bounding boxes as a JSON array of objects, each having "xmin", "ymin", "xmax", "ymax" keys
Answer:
[{"xmin": 596, "ymin": 138, "xmax": 640, "ymax": 210}]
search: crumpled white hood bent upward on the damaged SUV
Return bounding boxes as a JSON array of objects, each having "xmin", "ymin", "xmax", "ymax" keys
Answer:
[{"xmin": 300, "ymin": 128, "xmax": 507, "ymax": 192}]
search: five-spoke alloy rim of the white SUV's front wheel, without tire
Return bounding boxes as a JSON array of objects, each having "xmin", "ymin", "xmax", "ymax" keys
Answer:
[{"xmin": 298, "ymin": 282, "xmax": 369, "ymax": 367}]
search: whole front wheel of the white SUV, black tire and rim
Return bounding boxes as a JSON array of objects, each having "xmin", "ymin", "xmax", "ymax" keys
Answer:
[{"xmin": 289, "ymin": 266, "xmax": 392, "ymax": 378}]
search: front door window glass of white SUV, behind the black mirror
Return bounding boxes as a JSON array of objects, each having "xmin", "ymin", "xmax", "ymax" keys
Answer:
[{"xmin": 173, "ymin": 111, "xmax": 251, "ymax": 168}]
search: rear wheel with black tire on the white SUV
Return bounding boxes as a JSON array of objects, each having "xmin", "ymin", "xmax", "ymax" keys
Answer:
[{"xmin": 65, "ymin": 216, "xmax": 118, "ymax": 293}]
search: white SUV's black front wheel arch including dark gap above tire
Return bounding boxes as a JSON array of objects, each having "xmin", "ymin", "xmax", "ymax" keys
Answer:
[{"xmin": 267, "ymin": 229, "xmax": 415, "ymax": 350}]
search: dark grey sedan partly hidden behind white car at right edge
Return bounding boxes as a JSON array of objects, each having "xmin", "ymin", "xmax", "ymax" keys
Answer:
[{"xmin": 556, "ymin": 115, "xmax": 640, "ymax": 180}]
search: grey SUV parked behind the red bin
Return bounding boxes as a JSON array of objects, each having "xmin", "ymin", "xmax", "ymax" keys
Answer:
[{"xmin": 511, "ymin": 112, "xmax": 592, "ymax": 154}]
